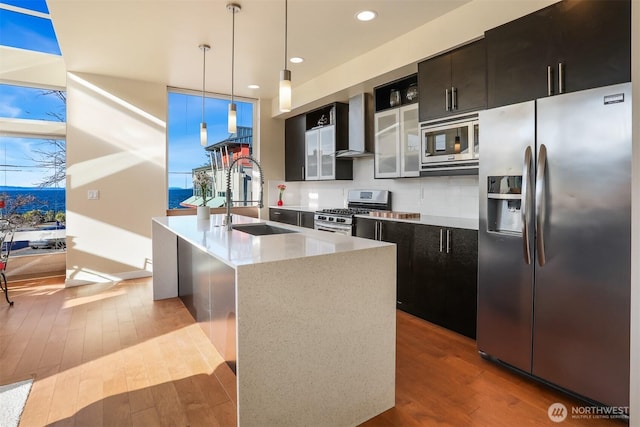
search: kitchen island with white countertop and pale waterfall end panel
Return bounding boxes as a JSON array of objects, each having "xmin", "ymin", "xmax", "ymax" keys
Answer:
[{"xmin": 152, "ymin": 215, "xmax": 396, "ymax": 426}]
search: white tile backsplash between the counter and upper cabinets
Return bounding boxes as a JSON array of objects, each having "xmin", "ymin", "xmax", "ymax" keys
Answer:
[{"xmin": 265, "ymin": 158, "xmax": 479, "ymax": 218}]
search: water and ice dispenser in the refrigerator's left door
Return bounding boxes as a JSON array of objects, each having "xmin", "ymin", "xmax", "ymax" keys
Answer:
[{"xmin": 487, "ymin": 175, "xmax": 522, "ymax": 235}]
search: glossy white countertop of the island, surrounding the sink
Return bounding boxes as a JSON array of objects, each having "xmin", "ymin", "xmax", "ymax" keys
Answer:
[{"xmin": 153, "ymin": 215, "xmax": 389, "ymax": 267}]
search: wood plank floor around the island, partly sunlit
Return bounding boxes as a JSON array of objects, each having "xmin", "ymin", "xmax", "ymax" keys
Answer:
[{"xmin": 0, "ymin": 277, "xmax": 626, "ymax": 427}]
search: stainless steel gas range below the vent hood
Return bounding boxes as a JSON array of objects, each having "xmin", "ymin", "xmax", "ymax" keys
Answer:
[{"xmin": 314, "ymin": 190, "xmax": 391, "ymax": 236}]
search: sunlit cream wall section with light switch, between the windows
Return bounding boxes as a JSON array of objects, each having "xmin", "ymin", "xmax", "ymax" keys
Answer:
[{"xmin": 67, "ymin": 73, "xmax": 167, "ymax": 286}]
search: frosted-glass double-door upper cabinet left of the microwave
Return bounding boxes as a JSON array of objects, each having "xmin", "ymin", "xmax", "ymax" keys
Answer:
[{"xmin": 374, "ymin": 104, "xmax": 420, "ymax": 178}]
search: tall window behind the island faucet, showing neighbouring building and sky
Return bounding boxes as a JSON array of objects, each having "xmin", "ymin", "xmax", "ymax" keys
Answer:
[{"xmin": 167, "ymin": 90, "xmax": 254, "ymax": 209}]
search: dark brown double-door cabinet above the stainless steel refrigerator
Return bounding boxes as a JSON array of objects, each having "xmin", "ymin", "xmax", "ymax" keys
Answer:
[{"xmin": 485, "ymin": 0, "xmax": 631, "ymax": 108}]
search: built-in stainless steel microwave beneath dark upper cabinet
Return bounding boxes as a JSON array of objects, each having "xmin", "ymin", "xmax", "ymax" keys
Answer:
[{"xmin": 420, "ymin": 113, "xmax": 480, "ymax": 175}]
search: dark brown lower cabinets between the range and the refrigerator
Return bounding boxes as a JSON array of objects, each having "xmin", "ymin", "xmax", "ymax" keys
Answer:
[{"xmin": 356, "ymin": 218, "xmax": 478, "ymax": 338}]
